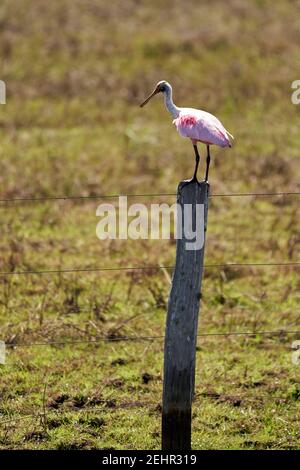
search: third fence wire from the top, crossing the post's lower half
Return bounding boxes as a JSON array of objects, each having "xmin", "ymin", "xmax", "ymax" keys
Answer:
[{"xmin": 5, "ymin": 328, "xmax": 300, "ymax": 348}]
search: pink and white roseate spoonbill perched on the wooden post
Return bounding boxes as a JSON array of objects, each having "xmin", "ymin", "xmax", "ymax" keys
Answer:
[{"xmin": 140, "ymin": 80, "xmax": 233, "ymax": 183}]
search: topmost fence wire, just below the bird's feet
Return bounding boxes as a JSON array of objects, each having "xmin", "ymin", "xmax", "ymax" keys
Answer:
[{"xmin": 0, "ymin": 191, "xmax": 300, "ymax": 204}]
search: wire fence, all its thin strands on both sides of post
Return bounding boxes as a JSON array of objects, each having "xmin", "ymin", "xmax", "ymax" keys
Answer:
[{"xmin": 0, "ymin": 186, "xmax": 300, "ymax": 440}]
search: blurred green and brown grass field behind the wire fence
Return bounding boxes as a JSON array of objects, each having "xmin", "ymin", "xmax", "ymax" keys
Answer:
[{"xmin": 0, "ymin": 0, "xmax": 300, "ymax": 449}]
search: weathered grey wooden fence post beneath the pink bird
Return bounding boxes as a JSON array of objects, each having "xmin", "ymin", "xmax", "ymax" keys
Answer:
[{"xmin": 162, "ymin": 178, "xmax": 209, "ymax": 450}]
